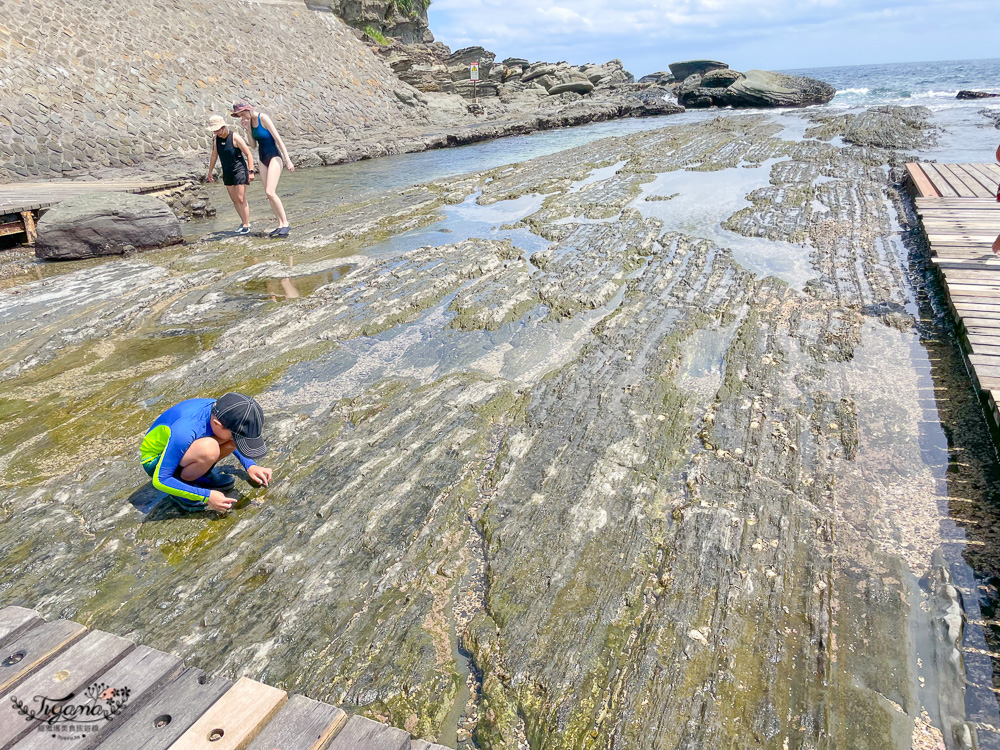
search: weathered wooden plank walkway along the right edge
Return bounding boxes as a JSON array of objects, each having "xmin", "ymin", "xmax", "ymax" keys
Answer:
[{"xmin": 906, "ymin": 163, "xmax": 1000, "ymax": 429}]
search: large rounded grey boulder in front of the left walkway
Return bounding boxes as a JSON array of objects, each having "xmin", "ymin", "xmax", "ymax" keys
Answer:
[{"xmin": 35, "ymin": 193, "xmax": 183, "ymax": 260}]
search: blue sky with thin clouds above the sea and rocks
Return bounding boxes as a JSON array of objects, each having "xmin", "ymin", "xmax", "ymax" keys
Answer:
[{"xmin": 430, "ymin": 0, "xmax": 1000, "ymax": 77}]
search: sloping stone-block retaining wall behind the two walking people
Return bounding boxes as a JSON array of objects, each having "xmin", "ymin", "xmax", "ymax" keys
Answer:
[{"xmin": 0, "ymin": 0, "xmax": 412, "ymax": 181}]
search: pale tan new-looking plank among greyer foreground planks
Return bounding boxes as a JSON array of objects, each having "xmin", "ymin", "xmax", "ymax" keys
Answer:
[{"xmin": 170, "ymin": 677, "xmax": 288, "ymax": 750}]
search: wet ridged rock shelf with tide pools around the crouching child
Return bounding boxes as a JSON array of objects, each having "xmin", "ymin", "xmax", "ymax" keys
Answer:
[{"xmin": 0, "ymin": 110, "xmax": 1000, "ymax": 750}]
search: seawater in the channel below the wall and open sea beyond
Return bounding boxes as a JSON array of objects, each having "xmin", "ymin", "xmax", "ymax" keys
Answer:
[{"xmin": 185, "ymin": 59, "xmax": 1000, "ymax": 239}]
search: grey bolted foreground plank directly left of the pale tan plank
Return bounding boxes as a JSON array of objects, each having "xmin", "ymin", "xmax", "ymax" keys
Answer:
[{"xmin": 101, "ymin": 667, "xmax": 233, "ymax": 750}]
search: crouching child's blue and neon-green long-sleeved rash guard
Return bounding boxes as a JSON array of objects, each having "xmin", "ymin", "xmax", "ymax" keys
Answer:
[{"xmin": 140, "ymin": 398, "xmax": 256, "ymax": 510}]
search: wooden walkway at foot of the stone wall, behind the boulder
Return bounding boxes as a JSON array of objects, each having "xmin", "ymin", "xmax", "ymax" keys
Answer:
[{"xmin": 0, "ymin": 180, "xmax": 183, "ymax": 244}]
